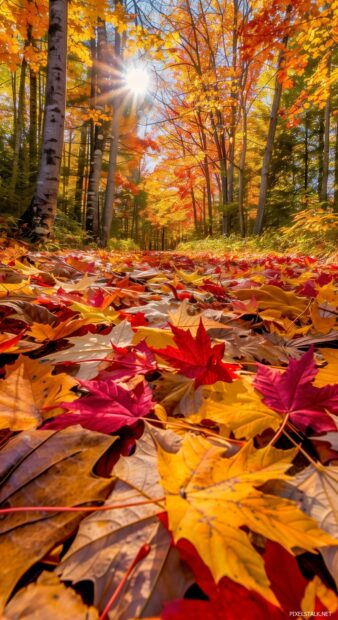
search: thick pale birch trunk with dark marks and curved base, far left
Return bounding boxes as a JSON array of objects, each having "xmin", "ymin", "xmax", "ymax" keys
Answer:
[{"xmin": 19, "ymin": 0, "xmax": 68, "ymax": 241}]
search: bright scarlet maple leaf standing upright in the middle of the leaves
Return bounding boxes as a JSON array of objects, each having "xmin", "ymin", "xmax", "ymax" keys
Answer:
[{"xmin": 155, "ymin": 320, "xmax": 239, "ymax": 388}]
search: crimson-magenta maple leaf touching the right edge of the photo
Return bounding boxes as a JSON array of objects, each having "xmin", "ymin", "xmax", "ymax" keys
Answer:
[{"xmin": 254, "ymin": 348, "xmax": 338, "ymax": 433}]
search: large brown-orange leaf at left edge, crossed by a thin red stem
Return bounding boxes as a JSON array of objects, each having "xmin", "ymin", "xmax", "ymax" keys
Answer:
[{"xmin": 0, "ymin": 427, "xmax": 114, "ymax": 609}]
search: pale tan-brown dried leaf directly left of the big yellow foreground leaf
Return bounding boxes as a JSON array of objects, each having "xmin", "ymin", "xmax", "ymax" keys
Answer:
[{"xmin": 57, "ymin": 428, "xmax": 193, "ymax": 620}]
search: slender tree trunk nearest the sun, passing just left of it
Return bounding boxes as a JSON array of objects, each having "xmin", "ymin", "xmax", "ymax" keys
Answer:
[{"xmin": 100, "ymin": 7, "xmax": 124, "ymax": 247}]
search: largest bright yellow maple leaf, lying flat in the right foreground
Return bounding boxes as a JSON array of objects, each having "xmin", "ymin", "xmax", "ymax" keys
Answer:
[{"xmin": 158, "ymin": 434, "xmax": 338, "ymax": 605}]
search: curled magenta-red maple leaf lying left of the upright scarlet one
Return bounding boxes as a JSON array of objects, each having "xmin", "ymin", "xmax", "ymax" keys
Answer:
[{"xmin": 43, "ymin": 381, "xmax": 154, "ymax": 434}]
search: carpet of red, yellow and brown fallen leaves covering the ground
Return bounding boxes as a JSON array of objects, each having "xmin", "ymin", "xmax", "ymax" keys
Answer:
[{"xmin": 0, "ymin": 244, "xmax": 338, "ymax": 620}]
